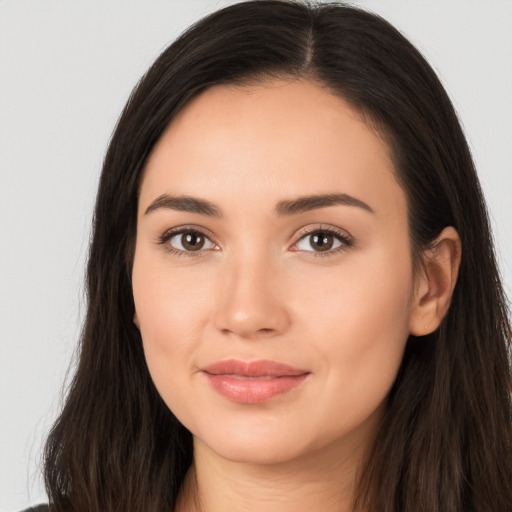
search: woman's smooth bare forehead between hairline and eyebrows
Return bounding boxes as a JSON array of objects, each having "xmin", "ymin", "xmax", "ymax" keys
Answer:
[{"xmin": 141, "ymin": 80, "xmax": 404, "ymax": 219}]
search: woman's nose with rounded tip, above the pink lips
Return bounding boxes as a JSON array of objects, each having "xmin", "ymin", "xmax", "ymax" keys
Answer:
[{"xmin": 214, "ymin": 255, "xmax": 290, "ymax": 339}]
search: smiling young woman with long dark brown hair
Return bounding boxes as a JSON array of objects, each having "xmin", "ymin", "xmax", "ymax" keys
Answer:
[{"xmin": 27, "ymin": 1, "xmax": 512, "ymax": 512}]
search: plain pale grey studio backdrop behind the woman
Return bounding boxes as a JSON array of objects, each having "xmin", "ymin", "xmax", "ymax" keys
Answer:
[{"xmin": 0, "ymin": 0, "xmax": 512, "ymax": 512}]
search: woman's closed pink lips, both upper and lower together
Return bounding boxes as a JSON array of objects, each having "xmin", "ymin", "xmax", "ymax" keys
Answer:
[{"xmin": 202, "ymin": 359, "xmax": 310, "ymax": 404}]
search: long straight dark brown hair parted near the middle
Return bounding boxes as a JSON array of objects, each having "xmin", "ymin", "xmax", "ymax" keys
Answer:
[{"xmin": 45, "ymin": 0, "xmax": 512, "ymax": 512}]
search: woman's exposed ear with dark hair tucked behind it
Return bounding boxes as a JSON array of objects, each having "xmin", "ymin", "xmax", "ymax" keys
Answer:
[{"xmin": 409, "ymin": 226, "xmax": 461, "ymax": 336}]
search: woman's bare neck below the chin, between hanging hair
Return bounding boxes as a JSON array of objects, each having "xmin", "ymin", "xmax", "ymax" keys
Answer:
[{"xmin": 176, "ymin": 439, "xmax": 363, "ymax": 512}]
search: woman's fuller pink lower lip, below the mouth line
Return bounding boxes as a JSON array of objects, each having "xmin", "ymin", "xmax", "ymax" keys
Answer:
[{"xmin": 205, "ymin": 372, "xmax": 309, "ymax": 404}]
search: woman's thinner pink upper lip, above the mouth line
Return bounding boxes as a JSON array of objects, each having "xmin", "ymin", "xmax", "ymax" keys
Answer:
[{"xmin": 202, "ymin": 359, "xmax": 309, "ymax": 377}]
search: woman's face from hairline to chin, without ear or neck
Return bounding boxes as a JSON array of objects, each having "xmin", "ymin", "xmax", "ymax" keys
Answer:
[{"xmin": 133, "ymin": 81, "xmax": 414, "ymax": 463}]
